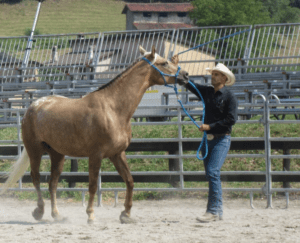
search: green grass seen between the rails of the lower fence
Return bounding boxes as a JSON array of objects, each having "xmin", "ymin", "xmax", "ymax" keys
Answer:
[{"xmin": 0, "ymin": 115, "xmax": 300, "ymax": 200}]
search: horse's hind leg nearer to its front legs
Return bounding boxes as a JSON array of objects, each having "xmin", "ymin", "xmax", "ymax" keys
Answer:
[{"xmin": 47, "ymin": 149, "xmax": 65, "ymax": 220}]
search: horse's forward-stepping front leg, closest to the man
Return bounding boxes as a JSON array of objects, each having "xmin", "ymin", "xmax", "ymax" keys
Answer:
[{"xmin": 110, "ymin": 151, "xmax": 135, "ymax": 224}]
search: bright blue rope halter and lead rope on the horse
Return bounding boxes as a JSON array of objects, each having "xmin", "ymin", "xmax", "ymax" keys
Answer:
[{"xmin": 142, "ymin": 57, "xmax": 208, "ymax": 160}]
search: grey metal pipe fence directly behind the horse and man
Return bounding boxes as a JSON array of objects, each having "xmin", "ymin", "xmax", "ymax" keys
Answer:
[{"xmin": 0, "ymin": 99, "xmax": 300, "ymax": 207}]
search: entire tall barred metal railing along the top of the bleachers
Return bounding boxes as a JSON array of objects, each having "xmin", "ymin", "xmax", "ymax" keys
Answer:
[{"xmin": 0, "ymin": 23, "xmax": 300, "ymax": 83}]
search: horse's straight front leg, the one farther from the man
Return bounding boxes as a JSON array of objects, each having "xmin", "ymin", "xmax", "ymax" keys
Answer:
[{"xmin": 86, "ymin": 153, "xmax": 102, "ymax": 224}]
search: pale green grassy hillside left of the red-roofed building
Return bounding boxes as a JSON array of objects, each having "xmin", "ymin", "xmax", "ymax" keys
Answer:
[{"xmin": 0, "ymin": 0, "xmax": 126, "ymax": 36}]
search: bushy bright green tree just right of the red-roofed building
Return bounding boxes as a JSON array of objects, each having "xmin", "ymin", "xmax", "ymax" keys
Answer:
[{"xmin": 190, "ymin": 0, "xmax": 272, "ymax": 26}]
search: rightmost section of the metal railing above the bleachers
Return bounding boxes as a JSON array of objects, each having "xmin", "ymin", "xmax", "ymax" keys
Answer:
[{"xmin": 245, "ymin": 23, "xmax": 300, "ymax": 72}]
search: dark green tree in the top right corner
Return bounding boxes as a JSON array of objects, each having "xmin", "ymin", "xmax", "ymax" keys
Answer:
[{"xmin": 262, "ymin": 0, "xmax": 300, "ymax": 24}]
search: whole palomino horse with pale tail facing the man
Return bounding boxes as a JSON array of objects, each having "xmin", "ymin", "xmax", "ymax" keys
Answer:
[{"xmin": 0, "ymin": 47, "xmax": 188, "ymax": 223}]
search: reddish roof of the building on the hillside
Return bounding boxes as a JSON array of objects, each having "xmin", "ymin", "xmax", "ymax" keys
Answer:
[{"xmin": 122, "ymin": 3, "xmax": 193, "ymax": 14}]
